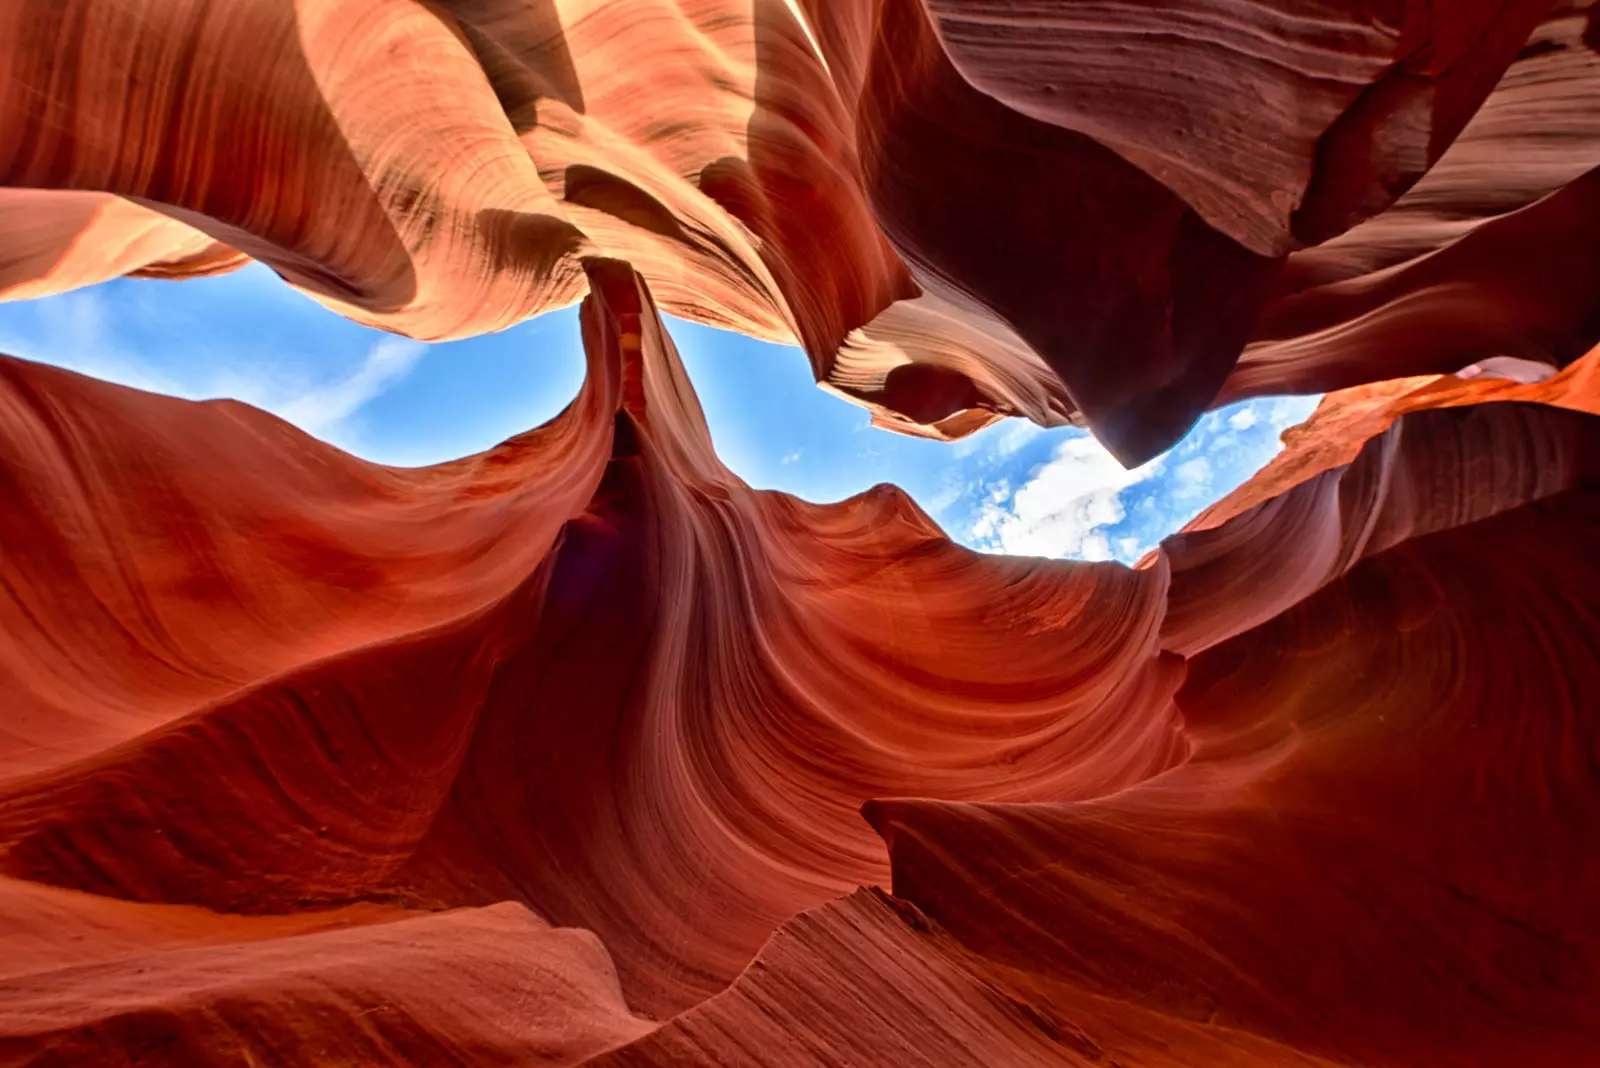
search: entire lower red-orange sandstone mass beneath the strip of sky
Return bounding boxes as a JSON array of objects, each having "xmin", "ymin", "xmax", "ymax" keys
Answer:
[{"xmin": 0, "ymin": 261, "xmax": 1600, "ymax": 1065}]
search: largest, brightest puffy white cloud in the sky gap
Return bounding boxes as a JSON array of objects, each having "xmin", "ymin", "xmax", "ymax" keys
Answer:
[{"xmin": 971, "ymin": 435, "xmax": 1163, "ymax": 560}]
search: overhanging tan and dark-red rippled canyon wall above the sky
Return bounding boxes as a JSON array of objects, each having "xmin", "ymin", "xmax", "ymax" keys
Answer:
[{"xmin": 0, "ymin": 0, "xmax": 1600, "ymax": 464}]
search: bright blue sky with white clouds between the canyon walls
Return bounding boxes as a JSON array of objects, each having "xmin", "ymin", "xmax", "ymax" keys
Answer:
[{"xmin": 0, "ymin": 265, "xmax": 1317, "ymax": 563}]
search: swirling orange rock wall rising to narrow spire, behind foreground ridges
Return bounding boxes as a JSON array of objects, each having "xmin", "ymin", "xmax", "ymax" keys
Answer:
[{"xmin": 0, "ymin": 261, "xmax": 1184, "ymax": 1057}]
